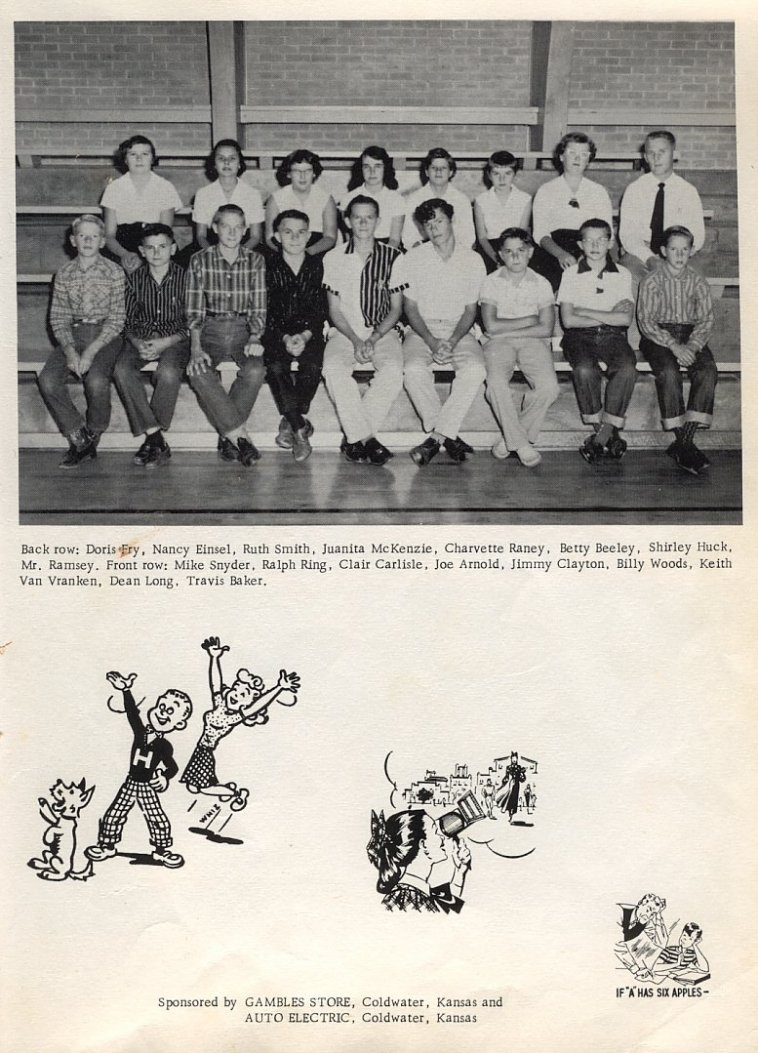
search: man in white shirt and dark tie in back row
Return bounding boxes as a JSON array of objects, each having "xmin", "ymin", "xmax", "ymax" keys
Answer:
[{"xmin": 619, "ymin": 131, "xmax": 705, "ymax": 281}]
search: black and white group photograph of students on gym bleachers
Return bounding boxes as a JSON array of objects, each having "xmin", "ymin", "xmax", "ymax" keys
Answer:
[{"xmin": 14, "ymin": 20, "xmax": 742, "ymax": 525}]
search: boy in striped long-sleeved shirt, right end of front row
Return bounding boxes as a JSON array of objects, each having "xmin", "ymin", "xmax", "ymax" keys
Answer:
[{"xmin": 637, "ymin": 226, "xmax": 718, "ymax": 475}]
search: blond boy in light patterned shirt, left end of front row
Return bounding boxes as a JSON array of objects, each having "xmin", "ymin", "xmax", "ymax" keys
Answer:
[{"xmin": 39, "ymin": 215, "xmax": 124, "ymax": 469}]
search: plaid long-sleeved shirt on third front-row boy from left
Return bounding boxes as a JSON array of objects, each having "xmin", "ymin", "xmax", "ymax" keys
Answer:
[{"xmin": 185, "ymin": 245, "xmax": 266, "ymax": 338}]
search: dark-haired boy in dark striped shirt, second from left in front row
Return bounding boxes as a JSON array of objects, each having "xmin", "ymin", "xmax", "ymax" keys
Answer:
[{"xmin": 114, "ymin": 223, "xmax": 190, "ymax": 469}]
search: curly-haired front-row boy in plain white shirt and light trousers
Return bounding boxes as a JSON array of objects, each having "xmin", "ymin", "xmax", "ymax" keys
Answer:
[{"xmin": 393, "ymin": 198, "xmax": 486, "ymax": 464}]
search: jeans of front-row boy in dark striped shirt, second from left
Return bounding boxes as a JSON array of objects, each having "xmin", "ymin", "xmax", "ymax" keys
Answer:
[{"xmin": 114, "ymin": 337, "xmax": 190, "ymax": 435}]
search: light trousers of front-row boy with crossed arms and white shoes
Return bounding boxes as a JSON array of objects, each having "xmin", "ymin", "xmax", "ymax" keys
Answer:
[{"xmin": 484, "ymin": 336, "xmax": 558, "ymax": 452}]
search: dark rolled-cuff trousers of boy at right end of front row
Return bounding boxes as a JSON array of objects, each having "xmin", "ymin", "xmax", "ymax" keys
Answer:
[{"xmin": 640, "ymin": 324, "xmax": 718, "ymax": 431}]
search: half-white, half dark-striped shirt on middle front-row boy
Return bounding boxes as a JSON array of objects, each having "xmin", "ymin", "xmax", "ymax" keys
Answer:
[{"xmin": 324, "ymin": 238, "xmax": 400, "ymax": 337}]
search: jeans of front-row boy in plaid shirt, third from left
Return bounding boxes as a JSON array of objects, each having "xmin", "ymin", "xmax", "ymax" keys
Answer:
[{"xmin": 187, "ymin": 317, "xmax": 265, "ymax": 436}]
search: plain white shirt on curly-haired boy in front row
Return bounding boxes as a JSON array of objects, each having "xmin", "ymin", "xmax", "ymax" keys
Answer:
[{"xmin": 392, "ymin": 241, "xmax": 486, "ymax": 323}]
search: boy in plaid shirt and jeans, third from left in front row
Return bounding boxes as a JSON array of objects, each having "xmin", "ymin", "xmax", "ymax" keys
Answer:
[{"xmin": 185, "ymin": 204, "xmax": 266, "ymax": 466}]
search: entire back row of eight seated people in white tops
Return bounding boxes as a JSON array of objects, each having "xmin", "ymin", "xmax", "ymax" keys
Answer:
[{"xmin": 97, "ymin": 130, "xmax": 705, "ymax": 291}]
